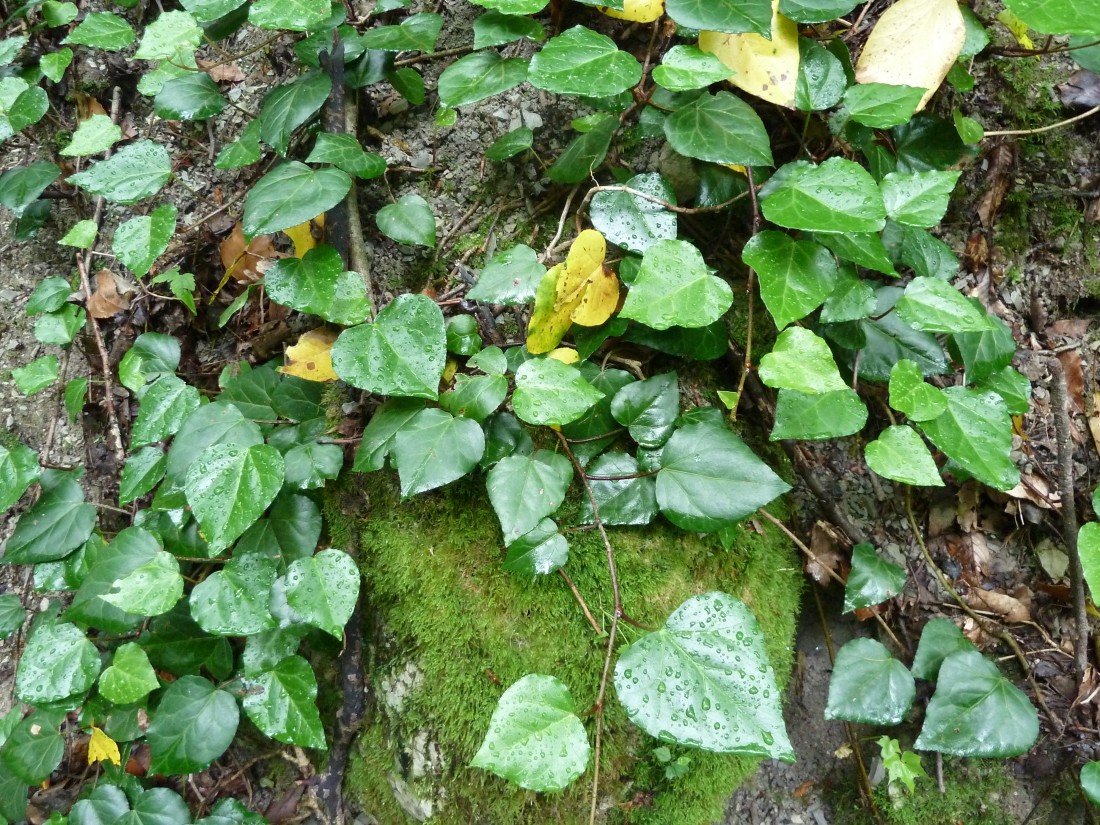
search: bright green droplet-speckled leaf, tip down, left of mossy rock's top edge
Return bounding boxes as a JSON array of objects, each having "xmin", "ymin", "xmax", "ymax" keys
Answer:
[{"xmin": 182, "ymin": 444, "xmax": 284, "ymax": 552}]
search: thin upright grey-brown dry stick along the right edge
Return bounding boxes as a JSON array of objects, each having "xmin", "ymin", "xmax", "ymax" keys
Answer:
[{"xmin": 1048, "ymin": 359, "xmax": 1089, "ymax": 688}]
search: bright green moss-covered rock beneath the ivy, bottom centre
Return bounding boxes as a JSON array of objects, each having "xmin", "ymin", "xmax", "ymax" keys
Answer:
[{"xmin": 327, "ymin": 472, "xmax": 802, "ymax": 825}]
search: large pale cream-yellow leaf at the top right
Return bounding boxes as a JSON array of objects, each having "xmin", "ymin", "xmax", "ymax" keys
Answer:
[{"xmin": 856, "ymin": 0, "xmax": 966, "ymax": 111}]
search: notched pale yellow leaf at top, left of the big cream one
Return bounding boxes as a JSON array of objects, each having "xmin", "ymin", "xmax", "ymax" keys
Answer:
[{"xmin": 699, "ymin": 0, "xmax": 799, "ymax": 109}]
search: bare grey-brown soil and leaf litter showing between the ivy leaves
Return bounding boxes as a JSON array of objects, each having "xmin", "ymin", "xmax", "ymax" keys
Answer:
[{"xmin": 0, "ymin": 2, "xmax": 1100, "ymax": 825}]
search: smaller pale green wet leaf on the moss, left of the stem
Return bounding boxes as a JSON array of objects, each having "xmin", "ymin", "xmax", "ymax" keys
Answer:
[{"xmin": 470, "ymin": 673, "xmax": 591, "ymax": 791}]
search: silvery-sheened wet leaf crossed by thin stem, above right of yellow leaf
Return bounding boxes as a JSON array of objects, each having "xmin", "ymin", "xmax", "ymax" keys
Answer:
[{"xmin": 589, "ymin": 173, "xmax": 677, "ymax": 253}]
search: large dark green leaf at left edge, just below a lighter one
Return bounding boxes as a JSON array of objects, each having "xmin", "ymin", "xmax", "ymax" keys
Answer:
[{"xmin": 2, "ymin": 475, "xmax": 96, "ymax": 564}]
